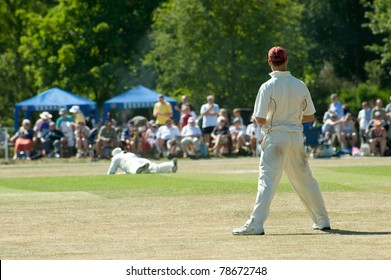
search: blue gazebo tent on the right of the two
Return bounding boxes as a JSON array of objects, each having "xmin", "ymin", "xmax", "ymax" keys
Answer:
[{"xmin": 102, "ymin": 86, "xmax": 179, "ymax": 122}]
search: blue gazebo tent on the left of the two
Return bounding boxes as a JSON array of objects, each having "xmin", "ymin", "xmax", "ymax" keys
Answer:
[{"xmin": 14, "ymin": 87, "xmax": 99, "ymax": 131}]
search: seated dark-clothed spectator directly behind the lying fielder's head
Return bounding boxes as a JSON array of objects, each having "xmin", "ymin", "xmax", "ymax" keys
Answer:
[{"xmin": 95, "ymin": 119, "xmax": 119, "ymax": 158}]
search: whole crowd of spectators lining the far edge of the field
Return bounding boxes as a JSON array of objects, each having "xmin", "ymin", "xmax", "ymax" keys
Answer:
[{"xmin": 6, "ymin": 94, "xmax": 391, "ymax": 160}]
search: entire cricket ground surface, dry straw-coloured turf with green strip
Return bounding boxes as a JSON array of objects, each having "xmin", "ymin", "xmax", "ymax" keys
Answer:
[{"xmin": 0, "ymin": 158, "xmax": 391, "ymax": 259}]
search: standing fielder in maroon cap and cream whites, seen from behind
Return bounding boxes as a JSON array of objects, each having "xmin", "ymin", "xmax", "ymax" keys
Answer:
[{"xmin": 232, "ymin": 47, "xmax": 331, "ymax": 235}]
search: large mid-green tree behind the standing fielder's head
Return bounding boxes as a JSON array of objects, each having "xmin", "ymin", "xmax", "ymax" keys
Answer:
[{"xmin": 145, "ymin": 0, "xmax": 305, "ymax": 108}]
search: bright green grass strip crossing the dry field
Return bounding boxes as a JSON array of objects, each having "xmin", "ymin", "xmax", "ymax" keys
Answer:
[{"xmin": 0, "ymin": 162, "xmax": 391, "ymax": 194}]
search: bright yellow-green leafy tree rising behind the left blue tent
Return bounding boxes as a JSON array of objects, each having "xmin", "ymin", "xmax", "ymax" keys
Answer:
[{"xmin": 19, "ymin": 0, "xmax": 160, "ymax": 104}]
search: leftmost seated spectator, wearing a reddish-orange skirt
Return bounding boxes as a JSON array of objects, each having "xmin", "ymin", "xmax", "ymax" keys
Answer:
[{"xmin": 10, "ymin": 119, "xmax": 35, "ymax": 160}]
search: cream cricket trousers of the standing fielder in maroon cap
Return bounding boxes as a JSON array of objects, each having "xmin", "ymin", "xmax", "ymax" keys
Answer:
[{"xmin": 248, "ymin": 131, "xmax": 330, "ymax": 230}]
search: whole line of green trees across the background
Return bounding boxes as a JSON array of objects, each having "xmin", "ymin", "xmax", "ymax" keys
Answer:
[{"xmin": 0, "ymin": 0, "xmax": 391, "ymax": 126}]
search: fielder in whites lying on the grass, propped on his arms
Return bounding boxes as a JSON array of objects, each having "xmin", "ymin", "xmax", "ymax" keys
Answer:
[{"xmin": 107, "ymin": 148, "xmax": 178, "ymax": 175}]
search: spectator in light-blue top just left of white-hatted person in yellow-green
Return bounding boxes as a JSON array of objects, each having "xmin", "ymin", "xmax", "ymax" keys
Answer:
[{"xmin": 56, "ymin": 108, "xmax": 75, "ymax": 155}]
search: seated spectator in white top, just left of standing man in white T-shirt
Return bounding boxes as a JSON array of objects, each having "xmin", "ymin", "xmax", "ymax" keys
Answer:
[{"xmin": 181, "ymin": 117, "xmax": 202, "ymax": 157}]
